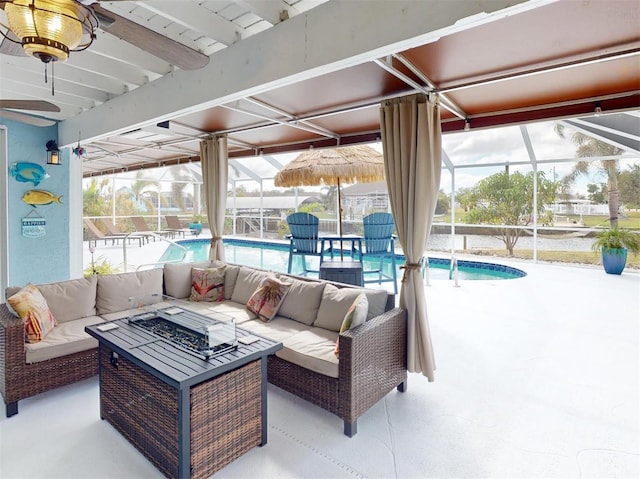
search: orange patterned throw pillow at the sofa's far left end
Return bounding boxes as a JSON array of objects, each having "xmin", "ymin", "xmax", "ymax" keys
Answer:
[{"xmin": 7, "ymin": 283, "xmax": 57, "ymax": 343}]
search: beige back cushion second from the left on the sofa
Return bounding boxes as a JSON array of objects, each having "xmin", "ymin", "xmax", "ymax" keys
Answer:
[{"xmin": 96, "ymin": 268, "xmax": 164, "ymax": 314}]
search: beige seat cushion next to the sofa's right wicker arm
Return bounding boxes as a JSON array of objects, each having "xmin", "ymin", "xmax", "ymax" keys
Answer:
[{"xmin": 276, "ymin": 328, "xmax": 338, "ymax": 378}]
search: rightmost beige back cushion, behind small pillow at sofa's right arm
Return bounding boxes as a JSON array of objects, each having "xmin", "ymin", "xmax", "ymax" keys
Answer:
[{"xmin": 313, "ymin": 284, "xmax": 388, "ymax": 331}]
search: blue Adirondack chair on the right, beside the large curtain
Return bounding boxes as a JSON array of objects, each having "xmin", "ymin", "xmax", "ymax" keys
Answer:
[{"xmin": 360, "ymin": 213, "xmax": 398, "ymax": 294}]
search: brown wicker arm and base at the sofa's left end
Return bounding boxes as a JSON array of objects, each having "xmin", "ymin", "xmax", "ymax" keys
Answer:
[{"xmin": 0, "ymin": 303, "xmax": 98, "ymax": 417}]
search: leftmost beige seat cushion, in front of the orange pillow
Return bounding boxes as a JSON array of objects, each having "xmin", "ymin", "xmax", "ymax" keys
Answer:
[{"xmin": 25, "ymin": 316, "xmax": 104, "ymax": 364}]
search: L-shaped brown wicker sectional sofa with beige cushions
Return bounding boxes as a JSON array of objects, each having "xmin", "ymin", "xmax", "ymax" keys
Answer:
[{"xmin": 0, "ymin": 262, "xmax": 407, "ymax": 436}]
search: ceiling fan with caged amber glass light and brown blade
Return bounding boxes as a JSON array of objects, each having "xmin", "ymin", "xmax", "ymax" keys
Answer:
[{"xmin": 0, "ymin": 0, "xmax": 209, "ymax": 70}]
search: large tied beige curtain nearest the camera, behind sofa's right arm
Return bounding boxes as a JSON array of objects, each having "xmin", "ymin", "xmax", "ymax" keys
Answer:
[{"xmin": 380, "ymin": 94, "xmax": 441, "ymax": 381}]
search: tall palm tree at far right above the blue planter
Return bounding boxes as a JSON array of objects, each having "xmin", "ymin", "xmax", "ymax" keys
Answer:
[{"xmin": 555, "ymin": 123, "xmax": 624, "ymax": 228}]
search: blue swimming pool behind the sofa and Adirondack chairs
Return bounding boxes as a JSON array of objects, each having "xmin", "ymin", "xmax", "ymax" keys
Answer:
[{"xmin": 159, "ymin": 238, "xmax": 527, "ymax": 280}]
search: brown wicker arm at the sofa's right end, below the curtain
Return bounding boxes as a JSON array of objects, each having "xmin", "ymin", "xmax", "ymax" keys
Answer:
[{"xmin": 339, "ymin": 308, "xmax": 407, "ymax": 436}]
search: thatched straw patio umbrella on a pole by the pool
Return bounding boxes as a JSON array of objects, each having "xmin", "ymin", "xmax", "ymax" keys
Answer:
[{"xmin": 273, "ymin": 145, "xmax": 384, "ymax": 236}]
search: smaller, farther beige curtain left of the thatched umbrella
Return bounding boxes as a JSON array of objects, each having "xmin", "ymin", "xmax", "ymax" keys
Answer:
[{"xmin": 200, "ymin": 136, "xmax": 229, "ymax": 260}]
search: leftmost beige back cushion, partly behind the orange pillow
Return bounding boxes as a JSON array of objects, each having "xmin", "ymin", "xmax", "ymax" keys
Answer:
[{"xmin": 5, "ymin": 276, "xmax": 98, "ymax": 323}]
